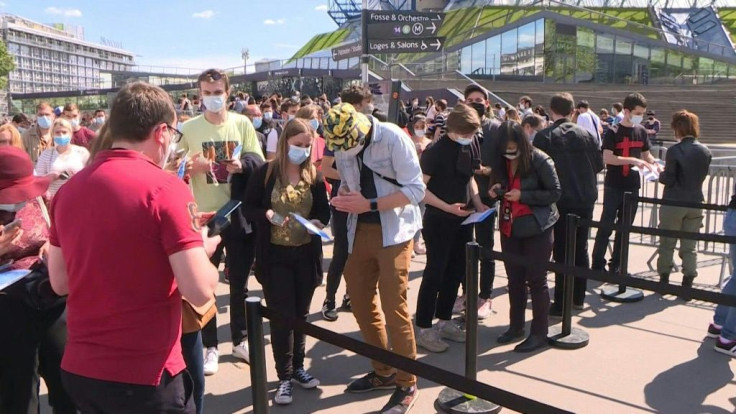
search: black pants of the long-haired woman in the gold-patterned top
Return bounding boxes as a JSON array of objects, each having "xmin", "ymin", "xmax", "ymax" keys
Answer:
[{"xmin": 263, "ymin": 244, "xmax": 317, "ymax": 381}]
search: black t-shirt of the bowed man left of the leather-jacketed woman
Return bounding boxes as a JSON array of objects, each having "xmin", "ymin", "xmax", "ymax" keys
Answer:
[{"xmin": 420, "ymin": 135, "xmax": 473, "ymax": 217}]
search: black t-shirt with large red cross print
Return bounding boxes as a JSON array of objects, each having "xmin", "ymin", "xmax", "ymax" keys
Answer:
[{"xmin": 603, "ymin": 124, "xmax": 649, "ymax": 190}]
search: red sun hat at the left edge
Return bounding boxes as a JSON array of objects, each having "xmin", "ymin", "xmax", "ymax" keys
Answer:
[{"xmin": 0, "ymin": 146, "xmax": 54, "ymax": 204}]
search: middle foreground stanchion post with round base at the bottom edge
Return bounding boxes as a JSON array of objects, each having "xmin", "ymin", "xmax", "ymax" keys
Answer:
[{"xmin": 435, "ymin": 242, "xmax": 501, "ymax": 414}]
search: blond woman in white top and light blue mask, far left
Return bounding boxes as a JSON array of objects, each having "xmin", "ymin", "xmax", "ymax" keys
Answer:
[{"xmin": 36, "ymin": 118, "xmax": 89, "ymax": 200}]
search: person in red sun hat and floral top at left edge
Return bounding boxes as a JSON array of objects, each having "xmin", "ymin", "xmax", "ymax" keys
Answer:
[{"xmin": 0, "ymin": 146, "xmax": 77, "ymax": 414}]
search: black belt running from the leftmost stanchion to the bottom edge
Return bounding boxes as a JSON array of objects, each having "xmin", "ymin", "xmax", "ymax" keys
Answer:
[{"xmin": 258, "ymin": 307, "xmax": 571, "ymax": 414}]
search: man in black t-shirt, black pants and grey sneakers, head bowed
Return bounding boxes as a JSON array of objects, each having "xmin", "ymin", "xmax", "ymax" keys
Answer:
[{"xmin": 416, "ymin": 104, "xmax": 488, "ymax": 352}]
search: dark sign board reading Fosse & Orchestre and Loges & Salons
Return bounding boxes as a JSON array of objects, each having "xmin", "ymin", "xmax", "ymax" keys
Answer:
[{"xmin": 363, "ymin": 10, "xmax": 445, "ymax": 54}]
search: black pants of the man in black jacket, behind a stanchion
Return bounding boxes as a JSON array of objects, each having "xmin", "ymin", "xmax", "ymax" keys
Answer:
[{"xmin": 552, "ymin": 206, "xmax": 593, "ymax": 309}]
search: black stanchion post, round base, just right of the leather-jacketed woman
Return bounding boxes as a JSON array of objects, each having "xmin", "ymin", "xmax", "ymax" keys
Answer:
[{"xmin": 548, "ymin": 214, "xmax": 590, "ymax": 349}]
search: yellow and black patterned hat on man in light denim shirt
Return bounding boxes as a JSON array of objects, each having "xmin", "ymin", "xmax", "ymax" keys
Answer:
[{"xmin": 322, "ymin": 103, "xmax": 371, "ymax": 151}]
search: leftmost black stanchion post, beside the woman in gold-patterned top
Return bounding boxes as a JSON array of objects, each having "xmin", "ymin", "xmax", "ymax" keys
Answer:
[{"xmin": 245, "ymin": 296, "xmax": 268, "ymax": 414}]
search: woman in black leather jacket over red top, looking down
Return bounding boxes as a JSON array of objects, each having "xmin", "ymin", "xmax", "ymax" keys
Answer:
[{"xmin": 489, "ymin": 122, "xmax": 562, "ymax": 352}]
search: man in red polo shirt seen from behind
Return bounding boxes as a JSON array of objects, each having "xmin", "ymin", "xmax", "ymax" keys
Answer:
[{"xmin": 49, "ymin": 82, "xmax": 219, "ymax": 413}]
